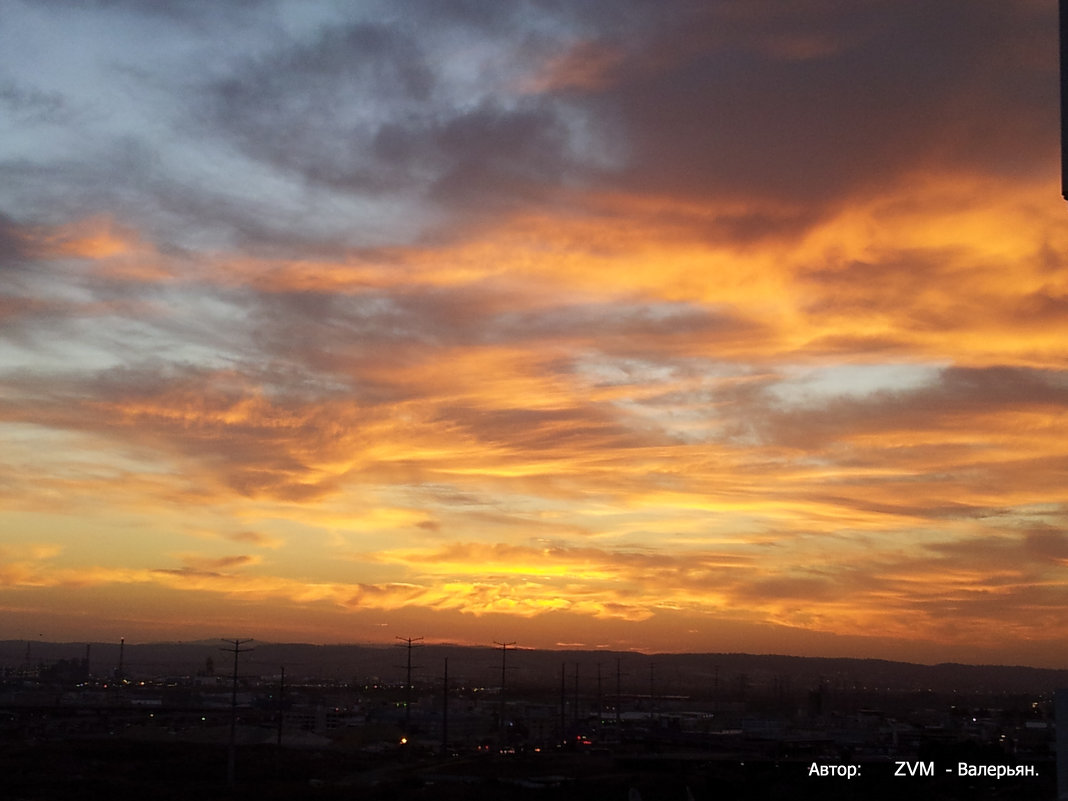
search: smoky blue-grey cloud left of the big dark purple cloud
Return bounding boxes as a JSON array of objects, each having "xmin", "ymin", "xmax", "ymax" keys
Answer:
[{"xmin": 192, "ymin": 16, "xmax": 610, "ymax": 230}]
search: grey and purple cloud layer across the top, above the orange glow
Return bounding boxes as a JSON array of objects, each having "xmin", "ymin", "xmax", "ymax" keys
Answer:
[{"xmin": 0, "ymin": 0, "xmax": 1056, "ymax": 252}]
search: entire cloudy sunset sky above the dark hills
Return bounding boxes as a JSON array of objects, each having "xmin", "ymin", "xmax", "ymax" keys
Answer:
[{"xmin": 0, "ymin": 0, "xmax": 1068, "ymax": 666}]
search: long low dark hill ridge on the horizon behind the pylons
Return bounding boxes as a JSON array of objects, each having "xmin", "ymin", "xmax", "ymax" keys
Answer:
[{"xmin": 0, "ymin": 640, "xmax": 1068, "ymax": 695}]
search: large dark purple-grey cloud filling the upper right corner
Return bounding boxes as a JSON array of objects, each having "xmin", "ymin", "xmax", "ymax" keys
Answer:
[{"xmin": 588, "ymin": 0, "xmax": 1056, "ymax": 210}]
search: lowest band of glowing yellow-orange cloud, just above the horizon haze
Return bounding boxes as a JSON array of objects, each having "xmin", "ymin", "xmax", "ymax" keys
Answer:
[{"xmin": 0, "ymin": 521, "xmax": 1068, "ymax": 647}]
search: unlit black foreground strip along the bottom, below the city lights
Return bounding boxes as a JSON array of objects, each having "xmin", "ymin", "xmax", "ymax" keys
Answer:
[{"xmin": 0, "ymin": 738, "xmax": 1056, "ymax": 801}]
